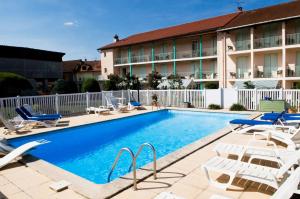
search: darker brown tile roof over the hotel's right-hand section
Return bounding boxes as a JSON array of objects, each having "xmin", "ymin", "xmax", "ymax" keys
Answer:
[{"xmin": 223, "ymin": 1, "xmax": 300, "ymax": 29}]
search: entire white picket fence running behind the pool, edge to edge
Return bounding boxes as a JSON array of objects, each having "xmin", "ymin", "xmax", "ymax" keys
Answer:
[{"xmin": 0, "ymin": 89, "xmax": 300, "ymax": 118}]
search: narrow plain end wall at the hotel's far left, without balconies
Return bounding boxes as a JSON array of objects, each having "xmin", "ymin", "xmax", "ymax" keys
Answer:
[{"xmin": 100, "ymin": 50, "xmax": 114, "ymax": 79}]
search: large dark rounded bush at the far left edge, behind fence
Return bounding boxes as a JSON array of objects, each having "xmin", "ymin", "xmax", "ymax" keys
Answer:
[{"xmin": 0, "ymin": 72, "xmax": 36, "ymax": 97}]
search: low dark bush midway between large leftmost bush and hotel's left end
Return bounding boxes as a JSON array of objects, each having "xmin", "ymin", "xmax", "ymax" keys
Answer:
[{"xmin": 51, "ymin": 79, "xmax": 78, "ymax": 94}]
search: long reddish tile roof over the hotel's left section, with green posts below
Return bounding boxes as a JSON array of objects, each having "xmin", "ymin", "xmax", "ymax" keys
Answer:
[{"xmin": 98, "ymin": 13, "xmax": 239, "ymax": 50}]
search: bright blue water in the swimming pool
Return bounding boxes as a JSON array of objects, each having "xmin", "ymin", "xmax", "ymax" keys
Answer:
[{"xmin": 9, "ymin": 110, "xmax": 247, "ymax": 184}]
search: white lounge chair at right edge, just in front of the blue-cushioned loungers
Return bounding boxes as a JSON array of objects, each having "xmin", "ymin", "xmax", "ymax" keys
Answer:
[{"xmin": 253, "ymin": 128, "xmax": 300, "ymax": 150}]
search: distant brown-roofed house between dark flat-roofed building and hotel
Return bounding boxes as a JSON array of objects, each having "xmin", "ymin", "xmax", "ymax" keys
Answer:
[{"xmin": 63, "ymin": 59, "xmax": 101, "ymax": 85}]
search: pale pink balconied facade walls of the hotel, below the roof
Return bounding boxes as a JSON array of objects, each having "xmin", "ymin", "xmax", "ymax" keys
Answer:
[{"xmin": 101, "ymin": 20, "xmax": 300, "ymax": 88}]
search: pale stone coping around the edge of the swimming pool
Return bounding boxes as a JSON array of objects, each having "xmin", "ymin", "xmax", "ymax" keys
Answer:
[{"xmin": 15, "ymin": 107, "xmax": 261, "ymax": 198}]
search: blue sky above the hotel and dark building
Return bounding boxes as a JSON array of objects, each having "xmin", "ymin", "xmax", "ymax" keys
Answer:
[{"xmin": 0, "ymin": 0, "xmax": 288, "ymax": 60}]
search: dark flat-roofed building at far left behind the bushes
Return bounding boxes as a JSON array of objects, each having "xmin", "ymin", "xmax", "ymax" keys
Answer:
[{"xmin": 0, "ymin": 45, "xmax": 65, "ymax": 92}]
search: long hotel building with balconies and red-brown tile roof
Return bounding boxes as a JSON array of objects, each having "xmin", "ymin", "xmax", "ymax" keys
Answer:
[{"xmin": 98, "ymin": 1, "xmax": 300, "ymax": 89}]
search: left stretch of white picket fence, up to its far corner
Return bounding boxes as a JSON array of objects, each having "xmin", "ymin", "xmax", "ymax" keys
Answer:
[{"xmin": 0, "ymin": 90, "xmax": 130, "ymax": 118}]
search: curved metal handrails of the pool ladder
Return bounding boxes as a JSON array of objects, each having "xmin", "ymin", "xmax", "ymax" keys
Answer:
[{"xmin": 107, "ymin": 142, "xmax": 157, "ymax": 190}]
